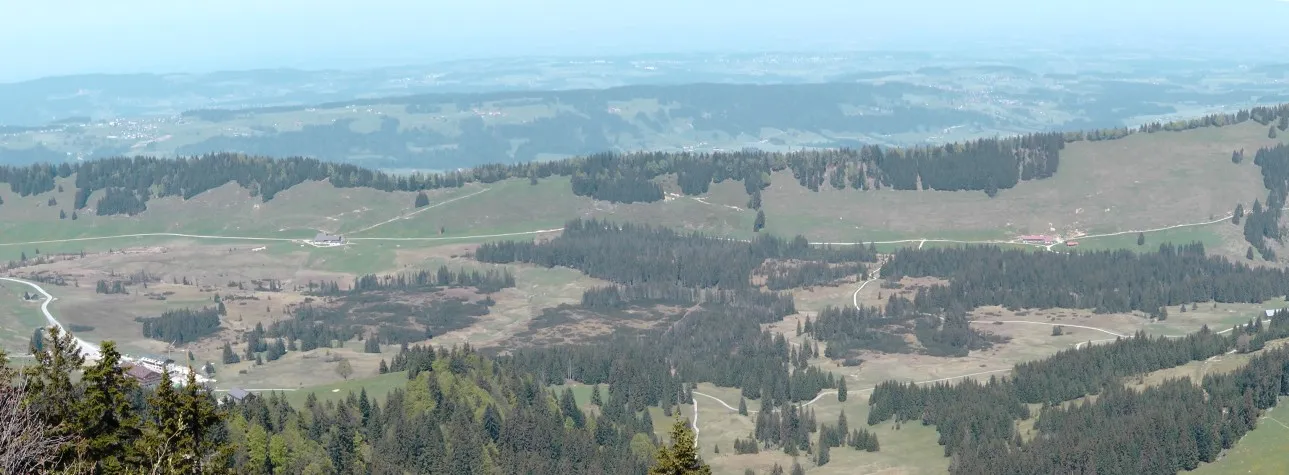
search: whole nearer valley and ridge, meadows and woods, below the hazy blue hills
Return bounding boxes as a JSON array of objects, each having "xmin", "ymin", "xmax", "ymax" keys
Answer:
[{"xmin": 0, "ymin": 99, "xmax": 1289, "ymax": 475}]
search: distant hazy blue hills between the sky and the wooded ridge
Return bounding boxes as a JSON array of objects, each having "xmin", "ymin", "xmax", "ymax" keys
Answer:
[{"xmin": 0, "ymin": 54, "xmax": 1285, "ymax": 170}]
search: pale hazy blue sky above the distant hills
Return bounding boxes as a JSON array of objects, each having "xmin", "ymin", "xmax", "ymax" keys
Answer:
[{"xmin": 0, "ymin": 0, "xmax": 1289, "ymax": 81}]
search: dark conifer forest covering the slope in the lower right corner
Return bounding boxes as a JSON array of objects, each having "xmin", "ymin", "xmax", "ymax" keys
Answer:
[{"xmin": 867, "ymin": 312, "xmax": 1289, "ymax": 475}]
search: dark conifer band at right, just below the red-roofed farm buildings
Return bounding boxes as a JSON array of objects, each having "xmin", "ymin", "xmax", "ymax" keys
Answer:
[{"xmin": 882, "ymin": 243, "xmax": 1289, "ymax": 318}]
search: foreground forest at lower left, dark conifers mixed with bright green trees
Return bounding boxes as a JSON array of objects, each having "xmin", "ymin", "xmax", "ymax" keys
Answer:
[{"xmin": 0, "ymin": 330, "xmax": 675, "ymax": 475}]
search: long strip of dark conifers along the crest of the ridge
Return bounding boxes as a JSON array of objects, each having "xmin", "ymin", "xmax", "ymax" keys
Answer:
[{"xmin": 0, "ymin": 104, "xmax": 1289, "ymax": 218}]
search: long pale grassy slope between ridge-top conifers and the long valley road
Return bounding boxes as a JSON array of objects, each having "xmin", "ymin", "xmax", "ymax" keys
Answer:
[{"xmin": 0, "ymin": 124, "xmax": 1275, "ymax": 258}]
